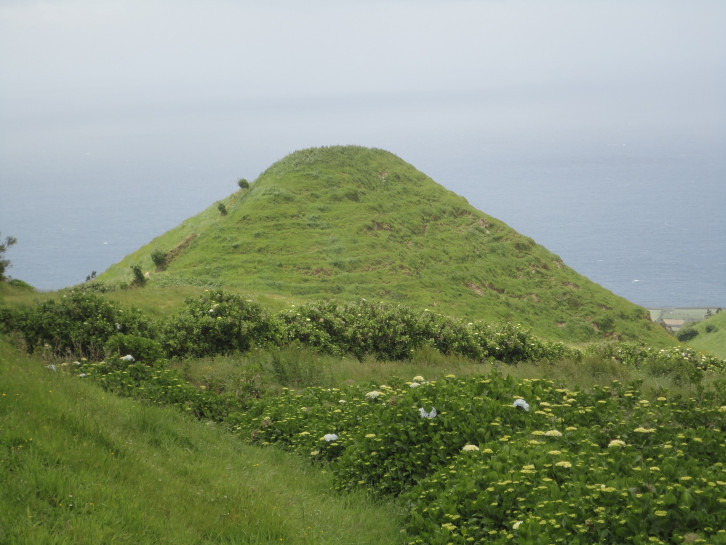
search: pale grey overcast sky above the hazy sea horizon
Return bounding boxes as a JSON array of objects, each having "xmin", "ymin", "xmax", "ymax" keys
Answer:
[{"xmin": 0, "ymin": 0, "xmax": 726, "ymax": 134}]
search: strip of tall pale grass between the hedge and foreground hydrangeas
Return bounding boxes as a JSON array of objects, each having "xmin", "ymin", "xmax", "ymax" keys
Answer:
[{"xmin": 172, "ymin": 344, "xmax": 723, "ymax": 399}]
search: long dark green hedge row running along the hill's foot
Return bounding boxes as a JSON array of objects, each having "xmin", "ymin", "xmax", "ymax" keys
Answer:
[{"xmin": 0, "ymin": 289, "xmax": 726, "ymax": 383}]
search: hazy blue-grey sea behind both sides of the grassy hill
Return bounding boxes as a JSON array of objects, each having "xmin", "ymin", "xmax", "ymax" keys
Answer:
[{"xmin": 0, "ymin": 125, "xmax": 726, "ymax": 307}]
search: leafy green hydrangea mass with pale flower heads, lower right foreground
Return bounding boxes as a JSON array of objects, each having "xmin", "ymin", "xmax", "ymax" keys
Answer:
[{"xmin": 235, "ymin": 372, "xmax": 726, "ymax": 544}]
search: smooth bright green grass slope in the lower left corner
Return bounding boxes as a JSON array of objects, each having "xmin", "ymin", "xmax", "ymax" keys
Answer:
[{"xmin": 0, "ymin": 340, "xmax": 401, "ymax": 545}]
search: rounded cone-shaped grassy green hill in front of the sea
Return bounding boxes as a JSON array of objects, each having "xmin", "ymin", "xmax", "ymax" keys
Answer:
[{"xmin": 100, "ymin": 142, "xmax": 668, "ymax": 344}]
